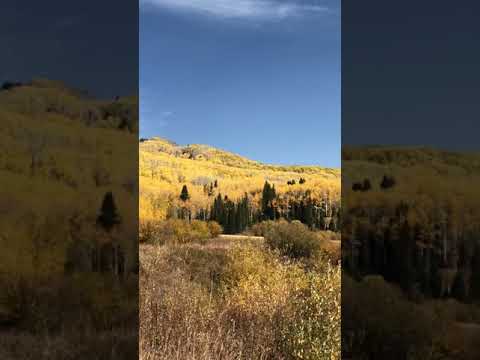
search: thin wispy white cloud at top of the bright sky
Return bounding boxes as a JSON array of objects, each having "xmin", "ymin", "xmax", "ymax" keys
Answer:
[{"xmin": 140, "ymin": 0, "xmax": 329, "ymax": 20}]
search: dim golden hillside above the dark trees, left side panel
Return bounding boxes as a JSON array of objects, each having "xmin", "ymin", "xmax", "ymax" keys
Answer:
[{"xmin": 0, "ymin": 80, "xmax": 138, "ymax": 277}]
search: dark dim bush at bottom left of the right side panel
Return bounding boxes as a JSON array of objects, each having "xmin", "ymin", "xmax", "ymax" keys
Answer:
[{"xmin": 342, "ymin": 274, "xmax": 455, "ymax": 359}]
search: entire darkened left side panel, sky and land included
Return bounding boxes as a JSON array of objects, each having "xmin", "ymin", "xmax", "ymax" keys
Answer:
[{"xmin": 0, "ymin": 0, "xmax": 138, "ymax": 360}]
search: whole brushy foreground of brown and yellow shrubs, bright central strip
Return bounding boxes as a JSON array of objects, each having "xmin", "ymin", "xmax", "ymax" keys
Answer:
[{"xmin": 140, "ymin": 236, "xmax": 340, "ymax": 360}]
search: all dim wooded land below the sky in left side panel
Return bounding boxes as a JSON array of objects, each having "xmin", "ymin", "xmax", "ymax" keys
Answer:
[{"xmin": 0, "ymin": 79, "xmax": 138, "ymax": 359}]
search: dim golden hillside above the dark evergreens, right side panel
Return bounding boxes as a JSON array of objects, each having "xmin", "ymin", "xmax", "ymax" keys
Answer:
[{"xmin": 342, "ymin": 146, "xmax": 480, "ymax": 212}]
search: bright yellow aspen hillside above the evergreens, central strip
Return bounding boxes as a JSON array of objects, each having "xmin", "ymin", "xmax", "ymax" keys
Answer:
[{"xmin": 140, "ymin": 137, "xmax": 340, "ymax": 220}]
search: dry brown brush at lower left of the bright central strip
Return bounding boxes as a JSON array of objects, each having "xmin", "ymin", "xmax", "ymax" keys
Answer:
[{"xmin": 139, "ymin": 245, "xmax": 242, "ymax": 360}]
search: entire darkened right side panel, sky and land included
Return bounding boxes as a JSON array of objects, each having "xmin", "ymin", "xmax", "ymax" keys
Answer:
[{"xmin": 342, "ymin": 0, "xmax": 480, "ymax": 360}]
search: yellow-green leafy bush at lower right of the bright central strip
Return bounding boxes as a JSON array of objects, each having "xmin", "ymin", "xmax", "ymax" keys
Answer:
[{"xmin": 224, "ymin": 246, "xmax": 341, "ymax": 359}]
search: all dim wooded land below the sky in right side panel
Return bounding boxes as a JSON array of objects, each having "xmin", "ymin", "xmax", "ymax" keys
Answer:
[{"xmin": 342, "ymin": 147, "xmax": 480, "ymax": 359}]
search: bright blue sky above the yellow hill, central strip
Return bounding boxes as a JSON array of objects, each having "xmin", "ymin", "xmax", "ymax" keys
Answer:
[{"xmin": 140, "ymin": 0, "xmax": 341, "ymax": 167}]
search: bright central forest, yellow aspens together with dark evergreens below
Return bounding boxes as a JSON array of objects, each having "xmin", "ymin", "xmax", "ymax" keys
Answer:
[{"xmin": 140, "ymin": 138, "xmax": 340, "ymax": 229}]
